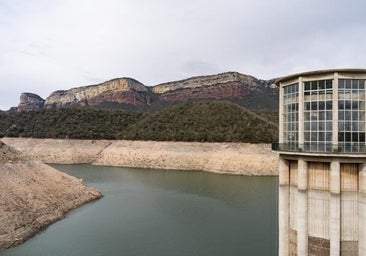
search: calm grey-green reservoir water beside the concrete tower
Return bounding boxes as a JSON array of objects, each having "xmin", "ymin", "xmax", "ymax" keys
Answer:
[{"xmin": 0, "ymin": 165, "xmax": 278, "ymax": 256}]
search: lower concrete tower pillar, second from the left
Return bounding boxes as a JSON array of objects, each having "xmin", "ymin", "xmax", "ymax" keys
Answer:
[{"xmin": 297, "ymin": 159, "xmax": 308, "ymax": 256}]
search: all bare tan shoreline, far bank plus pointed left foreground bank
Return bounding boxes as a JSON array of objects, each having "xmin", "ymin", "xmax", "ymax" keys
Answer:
[{"xmin": 0, "ymin": 138, "xmax": 278, "ymax": 251}]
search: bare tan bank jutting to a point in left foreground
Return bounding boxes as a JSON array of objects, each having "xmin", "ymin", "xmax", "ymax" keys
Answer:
[{"xmin": 0, "ymin": 142, "xmax": 102, "ymax": 251}]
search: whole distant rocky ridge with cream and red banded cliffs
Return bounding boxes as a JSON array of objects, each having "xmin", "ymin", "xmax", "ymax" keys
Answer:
[{"xmin": 11, "ymin": 72, "xmax": 278, "ymax": 112}]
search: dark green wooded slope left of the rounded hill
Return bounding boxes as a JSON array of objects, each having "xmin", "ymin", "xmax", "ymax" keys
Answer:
[{"xmin": 0, "ymin": 108, "xmax": 147, "ymax": 139}]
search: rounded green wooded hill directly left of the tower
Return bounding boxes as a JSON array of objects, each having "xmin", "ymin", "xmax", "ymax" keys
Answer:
[{"xmin": 118, "ymin": 101, "xmax": 277, "ymax": 143}]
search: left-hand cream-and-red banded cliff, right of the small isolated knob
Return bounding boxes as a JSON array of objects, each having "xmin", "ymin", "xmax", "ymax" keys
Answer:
[{"xmin": 45, "ymin": 78, "xmax": 151, "ymax": 108}]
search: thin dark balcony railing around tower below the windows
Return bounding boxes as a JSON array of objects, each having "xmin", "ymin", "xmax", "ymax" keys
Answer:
[{"xmin": 272, "ymin": 142, "xmax": 366, "ymax": 154}]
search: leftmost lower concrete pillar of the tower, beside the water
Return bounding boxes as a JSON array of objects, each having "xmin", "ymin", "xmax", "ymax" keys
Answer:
[{"xmin": 278, "ymin": 156, "xmax": 290, "ymax": 256}]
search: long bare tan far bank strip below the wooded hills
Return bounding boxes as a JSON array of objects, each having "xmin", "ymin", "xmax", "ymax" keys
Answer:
[{"xmin": 2, "ymin": 138, "xmax": 278, "ymax": 176}]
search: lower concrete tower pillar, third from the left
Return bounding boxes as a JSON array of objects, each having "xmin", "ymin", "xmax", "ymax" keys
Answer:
[{"xmin": 329, "ymin": 160, "xmax": 341, "ymax": 256}]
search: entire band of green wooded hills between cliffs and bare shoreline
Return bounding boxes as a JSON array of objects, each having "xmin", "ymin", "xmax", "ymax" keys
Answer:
[{"xmin": 0, "ymin": 101, "xmax": 277, "ymax": 143}]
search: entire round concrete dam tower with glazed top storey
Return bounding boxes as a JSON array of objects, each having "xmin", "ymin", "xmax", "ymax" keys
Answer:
[{"xmin": 273, "ymin": 69, "xmax": 366, "ymax": 256}]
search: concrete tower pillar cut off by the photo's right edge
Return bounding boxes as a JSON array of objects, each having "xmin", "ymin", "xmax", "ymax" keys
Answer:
[{"xmin": 358, "ymin": 163, "xmax": 366, "ymax": 256}]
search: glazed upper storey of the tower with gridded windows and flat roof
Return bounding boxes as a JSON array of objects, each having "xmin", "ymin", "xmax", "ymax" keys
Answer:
[{"xmin": 278, "ymin": 70, "xmax": 366, "ymax": 153}]
